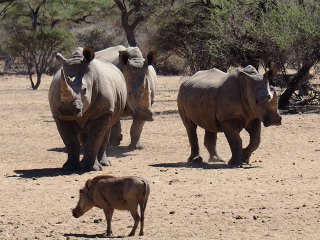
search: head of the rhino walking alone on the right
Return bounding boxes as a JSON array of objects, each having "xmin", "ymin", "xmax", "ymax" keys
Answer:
[{"xmin": 239, "ymin": 65, "xmax": 281, "ymax": 127}]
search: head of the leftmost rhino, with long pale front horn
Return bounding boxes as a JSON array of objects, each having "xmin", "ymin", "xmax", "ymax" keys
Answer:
[{"xmin": 56, "ymin": 48, "xmax": 94, "ymax": 117}]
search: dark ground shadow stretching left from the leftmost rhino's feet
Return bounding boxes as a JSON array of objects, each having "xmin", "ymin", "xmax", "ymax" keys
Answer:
[{"xmin": 9, "ymin": 168, "xmax": 75, "ymax": 179}]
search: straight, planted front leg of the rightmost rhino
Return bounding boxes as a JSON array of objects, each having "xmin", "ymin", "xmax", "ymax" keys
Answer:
[{"xmin": 223, "ymin": 121, "xmax": 245, "ymax": 166}]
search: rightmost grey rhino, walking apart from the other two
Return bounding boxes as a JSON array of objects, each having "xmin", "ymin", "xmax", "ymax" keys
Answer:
[{"xmin": 177, "ymin": 65, "xmax": 281, "ymax": 166}]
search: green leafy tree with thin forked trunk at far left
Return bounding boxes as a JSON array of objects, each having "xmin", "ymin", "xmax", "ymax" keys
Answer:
[{"xmin": 0, "ymin": 0, "xmax": 110, "ymax": 89}]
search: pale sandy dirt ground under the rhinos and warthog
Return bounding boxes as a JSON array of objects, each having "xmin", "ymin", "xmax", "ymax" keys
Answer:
[{"xmin": 0, "ymin": 76, "xmax": 320, "ymax": 240}]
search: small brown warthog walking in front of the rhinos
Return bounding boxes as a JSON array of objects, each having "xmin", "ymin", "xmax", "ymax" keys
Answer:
[{"xmin": 72, "ymin": 175, "xmax": 150, "ymax": 236}]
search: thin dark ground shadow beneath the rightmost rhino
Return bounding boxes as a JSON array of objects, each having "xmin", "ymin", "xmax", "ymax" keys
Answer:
[{"xmin": 149, "ymin": 162, "xmax": 256, "ymax": 169}]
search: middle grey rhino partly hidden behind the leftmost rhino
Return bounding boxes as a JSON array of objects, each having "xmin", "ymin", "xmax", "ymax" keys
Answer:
[{"xmin": 96, "ymin": 45, "xmax": 157, "ymax": 149}]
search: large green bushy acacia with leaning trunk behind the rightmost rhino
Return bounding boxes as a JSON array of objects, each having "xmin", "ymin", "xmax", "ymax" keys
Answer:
[{"xmin": 153, "ymin": 0, "xmax": 320, "ymax": 107}]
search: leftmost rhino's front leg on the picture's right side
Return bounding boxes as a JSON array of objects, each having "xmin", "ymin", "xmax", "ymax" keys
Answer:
[{"xmin": 81, "ymin": 115, "xmax": 111, "ymax": 171}]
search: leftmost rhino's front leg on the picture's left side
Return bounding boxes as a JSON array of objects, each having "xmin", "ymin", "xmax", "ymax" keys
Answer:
[{"xmin": 55, "ymin": 119, "xmax": 80, "ymax": 171}]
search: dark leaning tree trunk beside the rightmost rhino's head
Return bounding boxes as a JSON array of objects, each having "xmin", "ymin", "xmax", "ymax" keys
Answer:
[{"xmin": 279, "ymin": 61, "xmax": 316, "ymax": 109}]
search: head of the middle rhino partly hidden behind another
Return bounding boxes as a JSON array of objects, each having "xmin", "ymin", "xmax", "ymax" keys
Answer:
[{"xmin": 118, "ymin": 47, "xmax": 155, "ymax": 121}]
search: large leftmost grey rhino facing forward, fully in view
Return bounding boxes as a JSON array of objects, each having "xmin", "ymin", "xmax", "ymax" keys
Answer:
[{"xmin": 49, "ymin": 48, "xmax": 127, "ymax": 171}]
